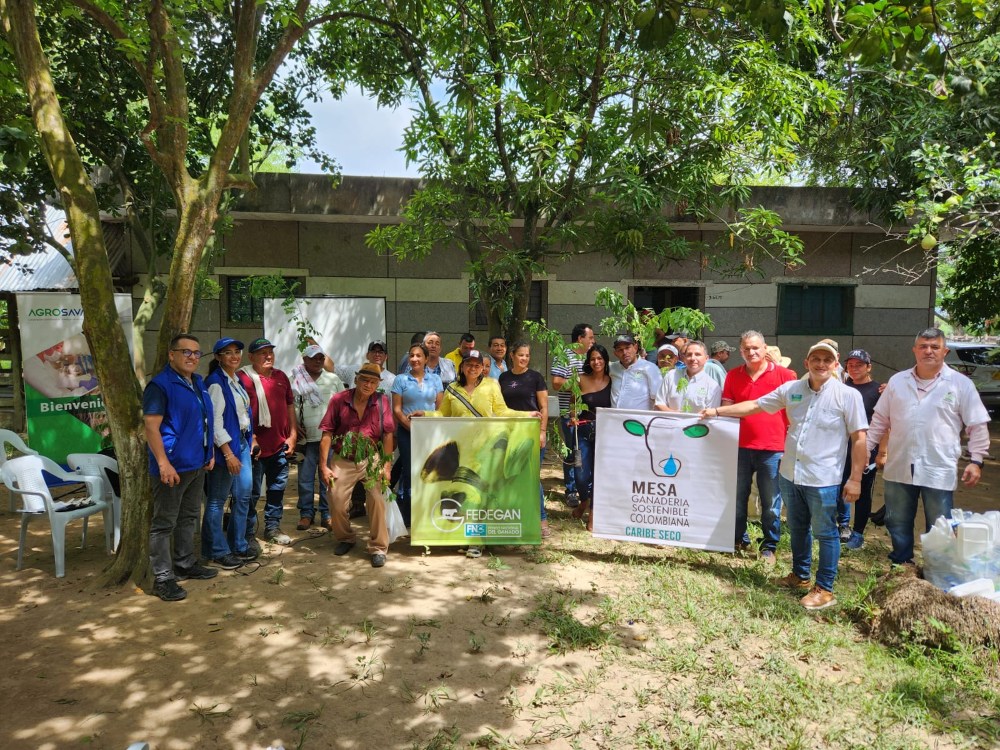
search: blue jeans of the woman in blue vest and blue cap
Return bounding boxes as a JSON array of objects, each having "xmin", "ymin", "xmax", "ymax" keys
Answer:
[{"xmin": 201, "ymin": 437, "xmax": 253, "ymax": 560}]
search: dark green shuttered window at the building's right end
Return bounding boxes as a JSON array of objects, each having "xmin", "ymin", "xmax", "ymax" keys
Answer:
[{"xmin": 778, "ymin": 284, "xmax": 854, "ymax": 336}]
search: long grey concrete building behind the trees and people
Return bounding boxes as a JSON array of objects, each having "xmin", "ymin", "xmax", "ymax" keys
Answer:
[{"xmin": 133, "ymin": 174, "xmax": 934, "ymax": 379}]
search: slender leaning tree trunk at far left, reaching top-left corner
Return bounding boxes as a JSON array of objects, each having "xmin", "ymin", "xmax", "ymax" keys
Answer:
[{"xmin": 0, "ymin": 0, "xmax": 150, "ymax": 583}]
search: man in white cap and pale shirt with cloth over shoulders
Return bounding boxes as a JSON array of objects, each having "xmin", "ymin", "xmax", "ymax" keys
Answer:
[{"xmin": 291, "ymin": 344, "xmax": 344, "ymax": 531}]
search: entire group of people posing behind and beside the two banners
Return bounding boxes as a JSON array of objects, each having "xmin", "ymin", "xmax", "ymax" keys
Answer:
[{"xmin": 143, "ymin": 323, "xmax": 989, "ymax": 609}]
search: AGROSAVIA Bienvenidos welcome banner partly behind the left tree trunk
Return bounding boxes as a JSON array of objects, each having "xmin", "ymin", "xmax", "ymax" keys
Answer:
[{"xmin": 17, "ymin": 292, "xmax": 132, "ymax": 463}]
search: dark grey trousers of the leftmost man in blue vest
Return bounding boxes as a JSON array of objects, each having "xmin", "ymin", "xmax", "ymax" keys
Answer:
[{"xmin": 149, "ymin": 469, "xmax": 205, "ymax": 582}]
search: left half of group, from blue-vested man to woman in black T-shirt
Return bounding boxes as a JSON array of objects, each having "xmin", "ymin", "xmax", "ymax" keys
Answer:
[{"xmin": 143, "ymin": 331, "xmax": 550, "ymax": 601}]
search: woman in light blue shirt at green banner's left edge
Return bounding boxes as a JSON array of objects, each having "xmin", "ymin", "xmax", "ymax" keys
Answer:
[{"xmin": 392, "ymin": 344, "xmax": 444, "ymax": 528}]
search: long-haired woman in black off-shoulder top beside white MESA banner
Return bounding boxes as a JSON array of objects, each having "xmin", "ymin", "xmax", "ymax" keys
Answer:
[{"xmin": 569, "ymin": 344, "xmax": 611, "ymax": 531}]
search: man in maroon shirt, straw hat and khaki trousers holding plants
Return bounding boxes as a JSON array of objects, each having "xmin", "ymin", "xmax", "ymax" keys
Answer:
[{"xmin": 319, "ymin": 362, "xmax": 396, "ymax": 568}]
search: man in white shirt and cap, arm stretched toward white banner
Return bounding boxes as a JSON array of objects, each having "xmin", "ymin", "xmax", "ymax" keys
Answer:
[{"xmin": 702, "ymin": 341, "xmax": 868, "ymax": 609}]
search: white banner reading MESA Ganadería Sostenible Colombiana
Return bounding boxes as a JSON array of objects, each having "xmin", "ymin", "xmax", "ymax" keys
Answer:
[{"xmin": 594, "ymin": 409, "xmax": 739, "ymax": 552}]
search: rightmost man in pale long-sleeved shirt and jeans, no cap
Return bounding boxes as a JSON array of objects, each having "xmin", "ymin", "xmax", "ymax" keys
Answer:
[{"xmin": 868, "ymin": 328, "xmax": 990, "ymax": 565}]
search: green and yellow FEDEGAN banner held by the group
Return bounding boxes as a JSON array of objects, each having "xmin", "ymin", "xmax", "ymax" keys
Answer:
[{"xmin": 410, "ymin": 417, "xmax": 542, "ymax": 546}]
